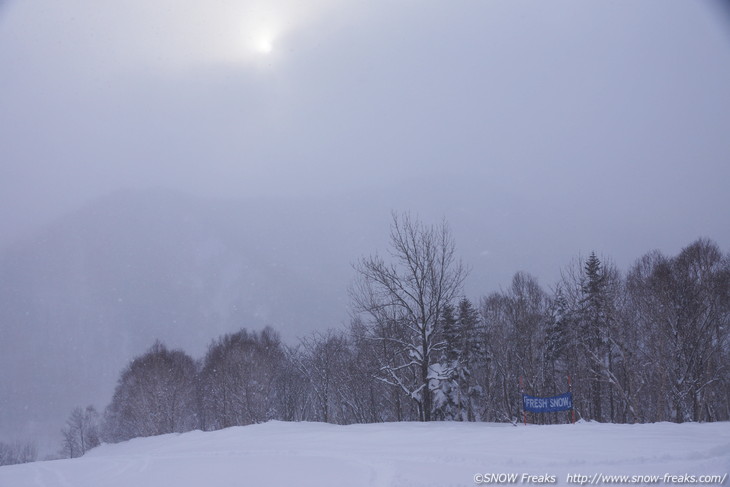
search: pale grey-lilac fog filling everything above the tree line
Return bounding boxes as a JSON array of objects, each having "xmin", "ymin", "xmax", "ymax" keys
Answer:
[{"xmin": 0, "ymin": 0, "xmax": 730, "ymax": 449}]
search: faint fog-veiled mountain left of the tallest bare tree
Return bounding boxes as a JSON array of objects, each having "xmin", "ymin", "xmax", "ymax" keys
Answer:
[{"xmin": 0, "ymin": 190, "xmax": 388, "ymax": 454}]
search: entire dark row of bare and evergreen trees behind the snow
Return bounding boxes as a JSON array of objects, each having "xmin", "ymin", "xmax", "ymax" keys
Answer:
[{"xmin": 58, "ymin": 214, "xmax": 730, "ymax": 457}]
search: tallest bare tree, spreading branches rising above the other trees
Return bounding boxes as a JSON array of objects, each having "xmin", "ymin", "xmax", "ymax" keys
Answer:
[{"xmin": 350, "ymin": 214, "xmax": 467, "ymax": 421}]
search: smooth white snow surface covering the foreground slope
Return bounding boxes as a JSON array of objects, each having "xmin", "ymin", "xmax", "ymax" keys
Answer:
[{"xmin": 0, "ymin": 421, "xmax": 730, "ymax": 487}]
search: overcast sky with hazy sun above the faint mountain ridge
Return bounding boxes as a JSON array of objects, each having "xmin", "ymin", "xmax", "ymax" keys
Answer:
[{"xmin": 0, "ymin": 0, "xmax": 730, "ymax": 258}]
